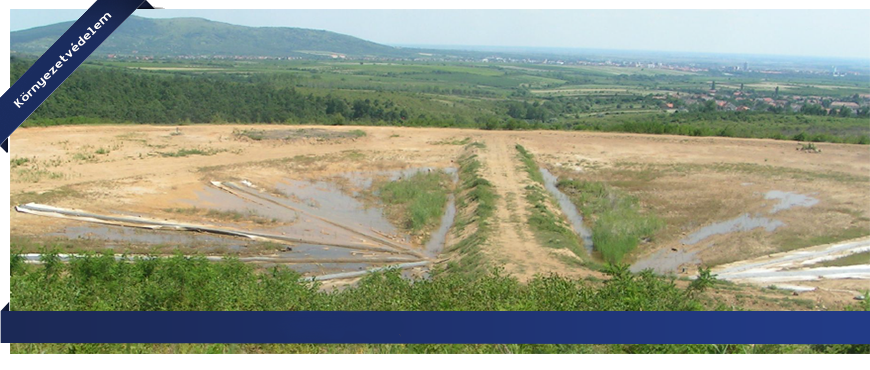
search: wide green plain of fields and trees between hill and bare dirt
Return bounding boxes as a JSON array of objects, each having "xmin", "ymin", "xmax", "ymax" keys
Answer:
[{"xmin": 12, "ymin": 58, "xmax": 870, "ymax": 144}]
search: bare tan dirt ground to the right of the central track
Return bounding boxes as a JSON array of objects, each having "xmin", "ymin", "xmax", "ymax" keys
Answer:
[{"xmin": 517, "ymin": 132, "xmax": 870, "ymax": 307}]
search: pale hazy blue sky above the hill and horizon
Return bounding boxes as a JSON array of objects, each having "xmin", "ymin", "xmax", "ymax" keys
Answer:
[{"xmin": 11, "ymin": 10, "xmax": 870, "ymax": 59}]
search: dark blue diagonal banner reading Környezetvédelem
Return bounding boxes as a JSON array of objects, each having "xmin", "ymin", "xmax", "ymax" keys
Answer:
[{"xmin": 0, "ymin": 0, "xmax": 150, "ymax": 139}]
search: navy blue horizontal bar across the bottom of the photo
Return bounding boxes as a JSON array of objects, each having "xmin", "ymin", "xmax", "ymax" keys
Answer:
[{"xmin": 0, "ymin": 311, "xmax": 870, "ymax": 344}]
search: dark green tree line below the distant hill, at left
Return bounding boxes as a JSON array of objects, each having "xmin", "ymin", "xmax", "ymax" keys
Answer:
[{"xmin": 12, "ymin": 58, "xmax": 411, "ymax": 125}]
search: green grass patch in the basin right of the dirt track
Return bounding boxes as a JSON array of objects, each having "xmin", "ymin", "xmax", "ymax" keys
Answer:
[{"xmin": 557, "ymin": 180, "xmax": 664, "ymax": 263}]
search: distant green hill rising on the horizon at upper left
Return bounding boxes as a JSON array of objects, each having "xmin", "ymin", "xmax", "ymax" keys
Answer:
[{"xmin": 10, "ymin": 16, "xmax": 419, "ymax": 58}]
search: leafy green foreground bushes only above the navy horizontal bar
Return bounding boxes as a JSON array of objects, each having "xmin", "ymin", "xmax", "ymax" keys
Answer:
[{"xmin": 10, "ymin": 253, "xmax": 705, "ymax": 311}]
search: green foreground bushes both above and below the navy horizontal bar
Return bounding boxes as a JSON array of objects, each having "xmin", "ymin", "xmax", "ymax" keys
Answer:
[{"xmin": 10, "ymin": 254, "xmax": 870, "ymax": 353}]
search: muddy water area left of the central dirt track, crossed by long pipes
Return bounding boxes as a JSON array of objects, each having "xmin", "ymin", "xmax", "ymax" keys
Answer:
[{"xmin": 44, "ymin": 168, "xmax": 457, "ymax": 274}]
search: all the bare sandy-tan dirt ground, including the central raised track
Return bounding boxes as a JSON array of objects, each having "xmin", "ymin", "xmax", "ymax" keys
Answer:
[{"xmin": 11, "ymin": 125, "xmax": 870, "ymax": 307}]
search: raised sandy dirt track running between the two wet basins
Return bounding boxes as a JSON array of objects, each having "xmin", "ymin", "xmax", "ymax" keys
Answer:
[{"xmin": 479, "ymin": 135, "xmax": 591, "ymax": 281}]
